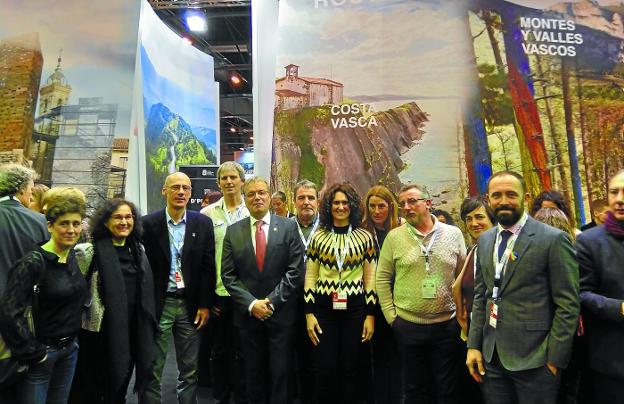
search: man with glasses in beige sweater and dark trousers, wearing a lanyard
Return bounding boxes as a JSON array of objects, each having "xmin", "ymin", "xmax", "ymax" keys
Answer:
[{"xmin": 376, "ymin": 184, "xmax": 466, "ymax": 404}]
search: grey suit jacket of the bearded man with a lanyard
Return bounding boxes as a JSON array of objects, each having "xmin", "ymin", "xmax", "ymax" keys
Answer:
[{"xmin": 468, "ymin": 217, "xmax": 580, "ymax": 371}]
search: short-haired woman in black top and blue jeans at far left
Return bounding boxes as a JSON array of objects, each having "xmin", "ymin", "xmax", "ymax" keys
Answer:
[{"xmin": 0, "ymin": 188, "xmax": 87, "ymax": 404}]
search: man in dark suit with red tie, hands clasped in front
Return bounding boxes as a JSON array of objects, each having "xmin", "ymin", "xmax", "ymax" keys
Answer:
[{"xmin": 221, "ymin": 177, "xmax": 304, "ymax": 404}]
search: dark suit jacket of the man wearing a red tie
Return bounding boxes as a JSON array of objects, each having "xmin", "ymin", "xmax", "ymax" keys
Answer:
[{"xmin": 221, "ymin": 215, "xmax": 304, "ymax": 327}]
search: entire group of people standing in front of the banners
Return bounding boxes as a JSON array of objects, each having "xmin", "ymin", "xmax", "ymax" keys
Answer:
[{"xmin": 0, "ymin": 162, "xmax": 624, "ymax": 404}]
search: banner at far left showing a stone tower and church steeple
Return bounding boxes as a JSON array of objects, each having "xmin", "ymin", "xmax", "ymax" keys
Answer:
[{"xmin": 0, "ymin": 0, "xmax": 139, "ymax": 208}]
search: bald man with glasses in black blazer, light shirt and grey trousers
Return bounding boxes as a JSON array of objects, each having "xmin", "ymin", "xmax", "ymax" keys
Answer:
[{"xmin": 142, "ymin": 172, "xmax": 215, "ymax": 404}]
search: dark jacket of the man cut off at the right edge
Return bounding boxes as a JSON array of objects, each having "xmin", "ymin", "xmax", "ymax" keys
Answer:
[{"xmin": 576, "ymin": 226, "xmax": 624, "ymax": 380}]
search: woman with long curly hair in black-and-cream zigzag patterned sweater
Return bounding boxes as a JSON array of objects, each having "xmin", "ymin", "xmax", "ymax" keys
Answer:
[{"xmin": 304, "ymin": 183, "xmax": 377, "ymax": 403}]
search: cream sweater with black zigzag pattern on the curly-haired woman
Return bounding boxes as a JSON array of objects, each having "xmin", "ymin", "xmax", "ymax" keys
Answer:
[{"xmin": 304, "ymin": 228, "xmax": 377, "ymax": 315}]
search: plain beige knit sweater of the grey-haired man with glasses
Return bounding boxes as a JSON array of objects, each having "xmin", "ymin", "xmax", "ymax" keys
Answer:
[{"xmin": 376, "ymin": 219, "xmax": 466, "ymax": 324}]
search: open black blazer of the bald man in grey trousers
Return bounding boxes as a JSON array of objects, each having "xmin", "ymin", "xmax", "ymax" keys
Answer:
[{"xmin": 143, "ymin": 209, "xmax": 216, "ymax": 321}]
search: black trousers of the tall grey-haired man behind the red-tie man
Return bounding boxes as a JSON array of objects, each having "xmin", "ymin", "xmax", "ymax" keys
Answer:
[{"xmin": 210, "ymin": 296, "xmax": 247, "ymax": 404}]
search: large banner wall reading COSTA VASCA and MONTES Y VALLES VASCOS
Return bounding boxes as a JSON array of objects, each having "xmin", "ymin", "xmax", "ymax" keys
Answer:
[{"xmin": 270, "ymin": 0, "xmax": 624, "ymax": 225}]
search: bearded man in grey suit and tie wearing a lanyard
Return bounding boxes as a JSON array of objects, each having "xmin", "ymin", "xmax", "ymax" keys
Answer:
[{"xmin": 466, "ymin": 171, "xmax": 580, "ymax": 404}]
